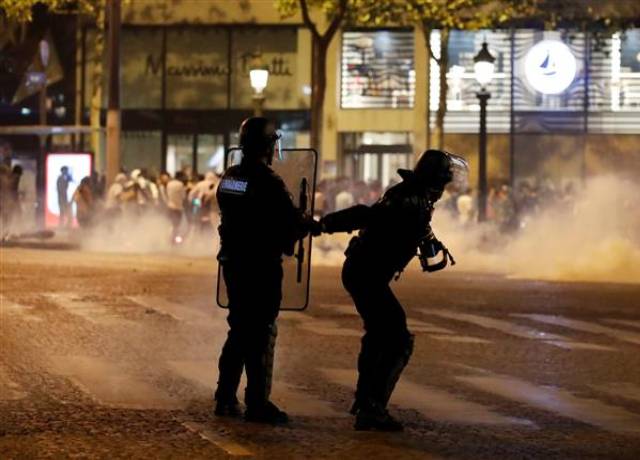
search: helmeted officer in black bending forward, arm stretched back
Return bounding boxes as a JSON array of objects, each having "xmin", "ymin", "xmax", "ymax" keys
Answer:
[{"xmin": 321, "ymin": 150, "xmax": 466, "ymax": 431}]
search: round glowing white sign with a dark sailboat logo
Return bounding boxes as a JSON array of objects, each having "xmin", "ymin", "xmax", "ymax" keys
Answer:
[{"xmin": 524, "ymin": 40, "xmax": 577, "ymax": 94}]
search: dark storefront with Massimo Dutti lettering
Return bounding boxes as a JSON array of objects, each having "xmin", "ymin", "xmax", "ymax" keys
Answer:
[{"xmin": 83, "ymin": 25, "xmax": 310, "ymax": 173}]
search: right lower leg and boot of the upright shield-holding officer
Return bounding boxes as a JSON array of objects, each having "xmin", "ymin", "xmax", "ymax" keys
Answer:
[{"xmin": 244, "ymin": 324, "xmax": 289, "ymax": 425}]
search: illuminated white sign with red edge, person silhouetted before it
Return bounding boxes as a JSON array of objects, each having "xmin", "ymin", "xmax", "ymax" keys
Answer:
[{"xmin": 45, "ymin": 153, "xmax": 93, "ymax": 227}]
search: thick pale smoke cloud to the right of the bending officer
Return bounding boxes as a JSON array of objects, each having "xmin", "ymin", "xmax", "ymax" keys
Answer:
[{"xmin": 433, "ymin": 176, "xmax": 640, "ymax": 283}]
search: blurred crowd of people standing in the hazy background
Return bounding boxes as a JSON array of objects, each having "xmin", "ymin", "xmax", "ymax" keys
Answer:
[{"xmin": 0, "ymin": 158, "xmax": 575, "ymax": 243}]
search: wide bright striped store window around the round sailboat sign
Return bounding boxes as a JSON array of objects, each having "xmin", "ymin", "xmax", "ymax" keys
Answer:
[{"xmin": 430, "ymin": 29, "xmax": 640, "ymax": 133}]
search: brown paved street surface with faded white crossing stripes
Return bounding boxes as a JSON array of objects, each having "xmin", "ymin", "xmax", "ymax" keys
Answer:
[{"xmin": 0, "ymin": 248, "xmax": 640, "ymax": 459}]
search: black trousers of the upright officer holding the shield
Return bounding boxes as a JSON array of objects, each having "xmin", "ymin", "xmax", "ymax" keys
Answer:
[{"xmin": 215, "ymin": 261, "xmax": 282, "ymax": 407}]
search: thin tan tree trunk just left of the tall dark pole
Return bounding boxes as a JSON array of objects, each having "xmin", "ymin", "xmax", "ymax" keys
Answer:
[{"xmin": 89, "ymin": 4, "xmax": 105, "ymax": 171}]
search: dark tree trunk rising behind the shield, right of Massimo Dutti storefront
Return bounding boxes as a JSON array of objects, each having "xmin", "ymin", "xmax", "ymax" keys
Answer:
[{"xmin": 310, "ymin": 38, "xmax": 329, "ymax": 154}]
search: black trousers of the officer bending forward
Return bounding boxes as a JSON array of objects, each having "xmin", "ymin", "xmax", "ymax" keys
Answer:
[{"xmin": 342, "ymin": 256, "xmax": 413, "ymax": 408}]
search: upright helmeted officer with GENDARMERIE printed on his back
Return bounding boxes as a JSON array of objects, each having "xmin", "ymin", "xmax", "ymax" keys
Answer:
[{"xmin": 215, "ymin": 117, "xmax": 312, "ymax": 424}]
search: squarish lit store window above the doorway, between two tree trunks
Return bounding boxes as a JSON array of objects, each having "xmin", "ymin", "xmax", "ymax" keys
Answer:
[{"xmin": 341, "ymin": 30, "xmax": 416, "ymax": 109}]
